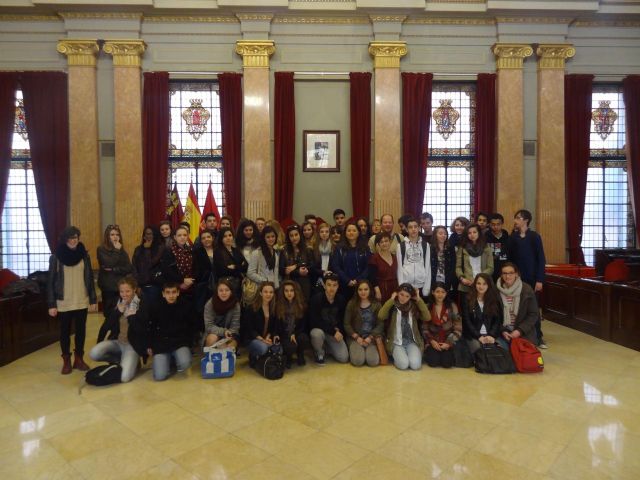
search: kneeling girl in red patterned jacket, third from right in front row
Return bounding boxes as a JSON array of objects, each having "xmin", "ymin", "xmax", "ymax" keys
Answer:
[{"xmin": 423, "ymin": 282, "xmax": 462, "ymax": 368}]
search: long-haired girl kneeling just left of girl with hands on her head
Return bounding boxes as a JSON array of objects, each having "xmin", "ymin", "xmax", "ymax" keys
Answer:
[{"xmin": 344, "ymin": 280, "xmax": 384, "ymax": 367}]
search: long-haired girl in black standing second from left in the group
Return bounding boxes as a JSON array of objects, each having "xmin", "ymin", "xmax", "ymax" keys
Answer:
[{"xmin": 98, "ymin": 225, "xmax": 133, "ymax": 342}]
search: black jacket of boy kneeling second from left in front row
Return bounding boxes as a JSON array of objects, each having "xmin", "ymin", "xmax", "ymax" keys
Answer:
[{"xmin": 145, "ymin": 297, "xmax": 193, "ymax": 354}]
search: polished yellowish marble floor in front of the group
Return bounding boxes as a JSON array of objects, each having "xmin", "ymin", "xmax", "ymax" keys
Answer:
[{"xmin": 0, "ymin": 315, "xmax": 640, "ymax": 480}]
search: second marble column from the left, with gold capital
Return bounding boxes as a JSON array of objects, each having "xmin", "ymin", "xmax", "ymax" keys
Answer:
[{"xmin": 103, "ymin": 40, "xmax": 146, "ymax": 254}]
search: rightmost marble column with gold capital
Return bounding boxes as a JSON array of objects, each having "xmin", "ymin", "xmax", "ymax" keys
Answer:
[{"xmin": 536, "ymin": 44, "xmax": 576, "ymax": 263}]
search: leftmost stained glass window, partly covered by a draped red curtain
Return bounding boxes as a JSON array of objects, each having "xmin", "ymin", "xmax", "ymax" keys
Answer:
[{"xmin": 0, "ymin": 90, "xmax": 51, "ymax": 277}]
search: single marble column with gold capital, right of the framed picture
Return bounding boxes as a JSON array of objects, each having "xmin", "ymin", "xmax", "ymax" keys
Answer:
[{"xmin": 369, "ymin": 42, "xmax": 407, "ymax": 220}]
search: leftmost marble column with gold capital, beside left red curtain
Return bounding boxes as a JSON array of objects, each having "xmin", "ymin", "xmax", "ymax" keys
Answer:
[{"xmin": 58, "ymin": 40, "xmax": 102, "ymax": 268}]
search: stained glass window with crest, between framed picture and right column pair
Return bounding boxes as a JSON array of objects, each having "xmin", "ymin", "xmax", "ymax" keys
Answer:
[{"xmin": 423, "ymin": 82, "xmax": 476, "ymax": 226}]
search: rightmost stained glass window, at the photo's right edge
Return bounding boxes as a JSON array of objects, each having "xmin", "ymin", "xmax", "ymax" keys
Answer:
[{"xmin": 582, "ymin": 84, "xmax": 635, "ymax": 265}]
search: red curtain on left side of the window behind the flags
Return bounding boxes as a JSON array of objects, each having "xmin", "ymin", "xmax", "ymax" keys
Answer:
[{"xmin": 142, "ymin": 72, "xmax": 171, "ymax": 225}]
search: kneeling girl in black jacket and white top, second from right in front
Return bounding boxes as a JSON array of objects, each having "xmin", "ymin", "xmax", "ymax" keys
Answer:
[{"xmin": 462, "ymin": 273, "xmax": 503, "ymax": 353}]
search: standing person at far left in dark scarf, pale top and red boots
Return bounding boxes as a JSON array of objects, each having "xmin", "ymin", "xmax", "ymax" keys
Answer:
[{"xmin": 47, "ymin": 226, "xmax": 98, "ymax": 375}]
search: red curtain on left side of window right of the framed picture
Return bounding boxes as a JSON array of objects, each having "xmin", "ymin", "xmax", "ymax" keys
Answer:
[{"xmin": 402, "ymin": 73, "xmax": 433, "ymax": 215}]
